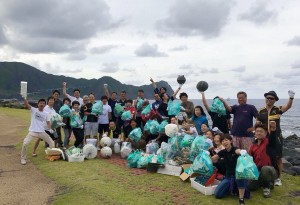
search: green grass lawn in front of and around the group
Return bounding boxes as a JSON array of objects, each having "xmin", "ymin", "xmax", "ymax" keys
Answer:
[{"xmin": 0, "ymin": 108, "xmax": 300, "ymax": 205}]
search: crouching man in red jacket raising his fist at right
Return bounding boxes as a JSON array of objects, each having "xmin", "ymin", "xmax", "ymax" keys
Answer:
[{"xmin": 248, "ymin": 121, "xmax": 279, "ymax": 198}]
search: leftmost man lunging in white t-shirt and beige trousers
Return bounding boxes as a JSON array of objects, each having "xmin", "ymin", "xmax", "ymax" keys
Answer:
[{"xmin": 21, "ymin": 99, "xmax": 54, "ymax": 165}]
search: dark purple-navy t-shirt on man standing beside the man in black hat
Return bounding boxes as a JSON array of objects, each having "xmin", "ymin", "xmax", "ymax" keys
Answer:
[{"xmin": 231, "ymin": 104, "xmax": 258, "ymax": 137}]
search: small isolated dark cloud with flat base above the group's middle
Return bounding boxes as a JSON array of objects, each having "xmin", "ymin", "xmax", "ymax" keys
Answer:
[{"xmin": 134, "ymin": 43, "xmax": 168, "ymax": 57}]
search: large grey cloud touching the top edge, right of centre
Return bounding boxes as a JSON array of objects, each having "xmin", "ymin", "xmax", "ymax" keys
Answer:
[{"xmin": 157, "ymin": 0, "xmax": 234, "ymax": 38}]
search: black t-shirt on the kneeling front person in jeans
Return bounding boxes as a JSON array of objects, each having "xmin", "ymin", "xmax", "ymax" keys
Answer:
[{"xmin": 217, "ymin": 147, "xmax": 240, "ymax": 177}]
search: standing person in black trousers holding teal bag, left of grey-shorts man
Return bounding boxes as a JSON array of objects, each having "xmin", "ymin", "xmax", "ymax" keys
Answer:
[{"xmin": 71, "ymin": 100, "xmax": 84, "ymax": 148}]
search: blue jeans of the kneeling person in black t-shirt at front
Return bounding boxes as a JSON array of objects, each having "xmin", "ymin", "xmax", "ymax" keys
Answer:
[{"xmin": 214, "ymin": 177, "xmax": 247, "ymax": 199}]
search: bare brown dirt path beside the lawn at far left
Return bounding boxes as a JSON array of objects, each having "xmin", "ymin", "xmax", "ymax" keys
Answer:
[{"xmin": 0, "ymin": 113, "xmax": 58, "ymax": 205}]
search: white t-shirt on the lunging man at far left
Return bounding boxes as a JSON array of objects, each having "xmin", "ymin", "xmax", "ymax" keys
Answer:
[{"xmin": 29, "ymin": 107, "xmax": 50, "ymax": 132}]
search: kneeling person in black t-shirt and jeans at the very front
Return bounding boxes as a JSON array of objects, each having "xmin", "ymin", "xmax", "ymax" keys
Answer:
[{"xmin": 212, "ymin": 134, "xmax": 248, "ymax": 204}]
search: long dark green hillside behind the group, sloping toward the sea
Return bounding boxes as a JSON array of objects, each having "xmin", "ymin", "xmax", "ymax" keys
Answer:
[{"xmin": 0, "ymin": 62, "xmax": 173, "ymax": 100}]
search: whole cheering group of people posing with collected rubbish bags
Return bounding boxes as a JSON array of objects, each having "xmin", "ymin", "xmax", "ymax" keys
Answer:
[{"xmin": 21, "ymin": 78, "xmax": 295, "ymax": 204}]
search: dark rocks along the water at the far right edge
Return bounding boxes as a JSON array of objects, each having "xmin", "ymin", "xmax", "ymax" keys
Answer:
[{"xmin": 283, "ymin": 134, "xmax": 300, "ymax": 175}]
